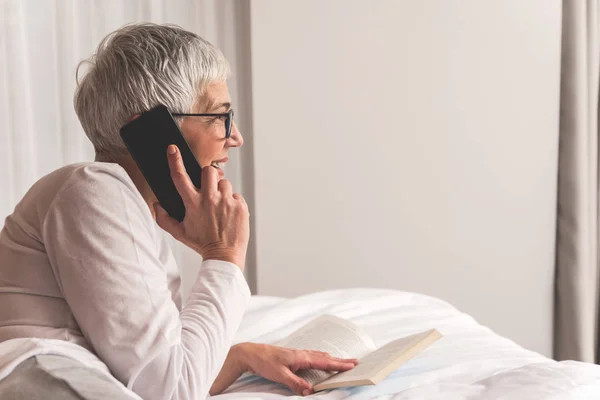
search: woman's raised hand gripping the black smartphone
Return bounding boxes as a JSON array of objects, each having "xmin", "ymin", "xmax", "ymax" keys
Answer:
[{"xmin": 154, "ymin": 145, "xmax": 250, "ymax": 270}]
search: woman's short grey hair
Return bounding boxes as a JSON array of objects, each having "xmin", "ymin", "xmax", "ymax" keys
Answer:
[{"xmin": 73, "ymin": 23, "xmax": 229, "ymax": 161}]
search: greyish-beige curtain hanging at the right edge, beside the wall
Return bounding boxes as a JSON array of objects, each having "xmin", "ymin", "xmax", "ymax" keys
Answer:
[{"xmin": 554, "ymin": 0, "xmax": 600, "ymax": 362}]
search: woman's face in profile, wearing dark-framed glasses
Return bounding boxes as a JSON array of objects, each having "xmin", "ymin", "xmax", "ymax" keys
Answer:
[{"xmin": 181, "ymin": 82, "xmax": 244, "ymax": 177}]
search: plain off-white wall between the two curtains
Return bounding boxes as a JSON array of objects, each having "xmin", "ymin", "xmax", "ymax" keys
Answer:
[{"xmin": 251, "ymin": 0, "xmax": 561, "ymax": 355}]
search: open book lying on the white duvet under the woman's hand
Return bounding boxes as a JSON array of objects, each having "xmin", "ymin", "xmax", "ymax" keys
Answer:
[{"xmin": 276, "ymin": 315, "xmax": 442, "ymax": 392}]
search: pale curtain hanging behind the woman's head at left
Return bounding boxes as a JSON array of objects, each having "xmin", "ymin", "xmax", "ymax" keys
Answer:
[{"xmin": 0, "ymin": 0, "xmax": 253, "ymax": 295}]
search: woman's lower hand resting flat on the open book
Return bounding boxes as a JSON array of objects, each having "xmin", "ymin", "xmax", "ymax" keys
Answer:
[{"xmin": 210, "ymin": 343, "xmax": 358, "ymax": 396}]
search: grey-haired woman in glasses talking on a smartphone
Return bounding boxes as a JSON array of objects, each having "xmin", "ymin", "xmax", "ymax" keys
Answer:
[{"xmin": 0, "ymin": 24, "xmax": 356, "ymax": 400}]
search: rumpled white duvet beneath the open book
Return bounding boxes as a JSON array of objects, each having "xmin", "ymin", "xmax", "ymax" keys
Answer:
[{"xmin": 215, "ymin": 289, "xmax": 600, "ymax": 400}]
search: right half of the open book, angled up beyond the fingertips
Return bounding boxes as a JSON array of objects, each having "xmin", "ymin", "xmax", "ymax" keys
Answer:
[{"xmin": 322, "ymin": 329, "xmax": 441, "ymax": 386}]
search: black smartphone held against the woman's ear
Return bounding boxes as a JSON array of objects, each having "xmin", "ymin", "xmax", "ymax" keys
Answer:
[{"xmin": 121, "ymin": 105, "xmax": 202, "ymax": 222}]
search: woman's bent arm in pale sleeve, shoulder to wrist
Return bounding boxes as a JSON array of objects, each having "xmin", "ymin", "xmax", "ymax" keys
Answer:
[{"xmin": 43, "ymin": 161, "xmax": 250, "ymax": 400}]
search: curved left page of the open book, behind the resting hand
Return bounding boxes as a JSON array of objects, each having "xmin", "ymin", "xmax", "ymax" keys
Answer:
[{"xmin": 275, "ymin": 315, "xmax": 376, "ymax": 385}]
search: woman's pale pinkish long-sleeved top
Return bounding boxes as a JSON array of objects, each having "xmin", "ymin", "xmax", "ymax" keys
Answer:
[{"xmin": 0, "ymin": 162, "xmax": 250, "ymax": 400}]
